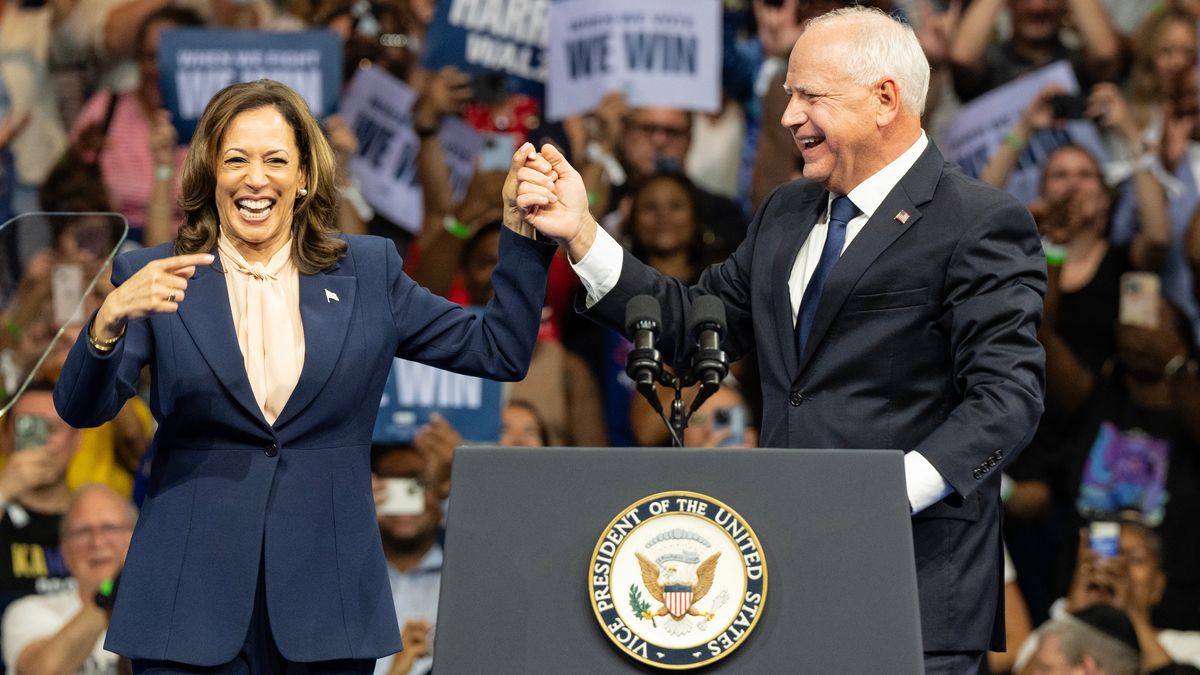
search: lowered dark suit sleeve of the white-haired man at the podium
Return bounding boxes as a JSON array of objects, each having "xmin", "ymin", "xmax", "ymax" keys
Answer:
[{"xmin": 912, "ymin": 192, "xmax": 1046, "ymax": 497}]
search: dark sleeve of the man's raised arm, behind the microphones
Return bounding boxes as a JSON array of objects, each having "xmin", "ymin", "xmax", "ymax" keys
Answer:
[{"xmin": 576, "ymin": 183, "xmax": 779, "ymax": 368}]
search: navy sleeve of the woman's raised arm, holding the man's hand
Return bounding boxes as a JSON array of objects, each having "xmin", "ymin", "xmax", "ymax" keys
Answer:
[{"xmin": 385, "ymin": 227, "xmax": 557, "ymax": 381}]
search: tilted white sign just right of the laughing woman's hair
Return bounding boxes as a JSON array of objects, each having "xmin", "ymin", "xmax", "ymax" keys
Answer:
[{"xmin": 338, "ymin": 67, "xmax": 425, "ymax": 234}]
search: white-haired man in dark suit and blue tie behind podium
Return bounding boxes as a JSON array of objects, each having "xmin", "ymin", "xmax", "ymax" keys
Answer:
[{"xmin": 517, "ymin": 7, "xmax": 1045, "ymax": 673}]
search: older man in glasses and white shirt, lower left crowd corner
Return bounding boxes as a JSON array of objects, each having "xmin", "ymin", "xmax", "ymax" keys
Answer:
[{"xmin": 0, "ymin": 484, "xmax": 137, "ymax": 675}]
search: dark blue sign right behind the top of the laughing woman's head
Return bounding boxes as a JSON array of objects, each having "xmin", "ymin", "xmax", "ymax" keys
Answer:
[{"xmin": 158, "ymin": 28, "xmax": 342, "ymax": 143}]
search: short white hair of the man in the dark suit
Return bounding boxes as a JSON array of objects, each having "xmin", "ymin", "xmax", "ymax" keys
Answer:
[{"xmin": 806, "ymin": 5, "xmax": 929, "ymax": 115}]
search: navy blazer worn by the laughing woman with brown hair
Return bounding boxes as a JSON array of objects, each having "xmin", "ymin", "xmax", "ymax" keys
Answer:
[{"xmin": 54, "ymin": 229, "xmax": 556, "ymax": 665}]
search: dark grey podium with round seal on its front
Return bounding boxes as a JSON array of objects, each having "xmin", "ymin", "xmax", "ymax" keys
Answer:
[{"xmin": 433, "ymin": 447, "xmax": 923, "ymax": 675}]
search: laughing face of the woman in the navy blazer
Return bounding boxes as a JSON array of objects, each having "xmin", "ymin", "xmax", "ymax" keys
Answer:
[{"xmin": 216, "ymin": 107, "xmax": 306, "ymax": 262}]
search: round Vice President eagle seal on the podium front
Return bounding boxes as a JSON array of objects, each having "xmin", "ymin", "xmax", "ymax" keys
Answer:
[{"xmin": 588, "ymin": 491, "xmax": 767, "ymax": 670}]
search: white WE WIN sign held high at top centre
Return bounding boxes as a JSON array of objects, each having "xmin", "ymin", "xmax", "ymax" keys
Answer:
[{"xmin": 546, "ymin": 0, "xmax": 721, "ymax": 120}]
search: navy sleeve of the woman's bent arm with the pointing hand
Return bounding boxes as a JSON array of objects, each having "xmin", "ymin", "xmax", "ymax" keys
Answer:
[{"xmin": 54, "ymin": 249, "xmax": 154, "ymax": 429}]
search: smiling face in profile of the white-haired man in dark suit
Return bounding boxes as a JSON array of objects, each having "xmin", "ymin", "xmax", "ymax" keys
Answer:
[{"xmin": 781, "ymin": 24, "xmax": 887, "ymax": 195}]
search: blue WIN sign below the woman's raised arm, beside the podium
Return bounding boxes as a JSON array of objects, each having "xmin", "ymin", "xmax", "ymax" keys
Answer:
[{"xmin": 371, "ymin": 359, "xmax": 500, "ymax": 443}]
